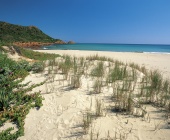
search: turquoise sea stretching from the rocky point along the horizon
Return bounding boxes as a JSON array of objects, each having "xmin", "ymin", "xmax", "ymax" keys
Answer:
[{"xmin": 42, "ymin": 43, "xmax": 170, "ymax": 53}]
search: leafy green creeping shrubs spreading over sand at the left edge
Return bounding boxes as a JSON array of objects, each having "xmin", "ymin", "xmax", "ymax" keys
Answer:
[{"xmin": 0, "ymin": 53, "xmax": 43, "ymax": 140}]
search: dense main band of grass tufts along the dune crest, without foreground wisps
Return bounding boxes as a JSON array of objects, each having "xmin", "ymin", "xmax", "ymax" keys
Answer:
[{"xmin": 52, "ymin": 55, "xmax": 170, "ymax": 116}]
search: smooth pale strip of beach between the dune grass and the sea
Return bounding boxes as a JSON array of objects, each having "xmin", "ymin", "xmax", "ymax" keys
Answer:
[{"xmin": 35, "ymin": 50, "xmax": 170, "ymax": 79}]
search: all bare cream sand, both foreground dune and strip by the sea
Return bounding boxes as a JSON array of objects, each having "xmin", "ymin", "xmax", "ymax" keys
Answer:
[{"xmin": 15, "ymin": 50, "xmax": 170, "ymax": 140}]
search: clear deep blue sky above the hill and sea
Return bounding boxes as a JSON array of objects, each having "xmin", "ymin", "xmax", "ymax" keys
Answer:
[{"xmin": 0, "ymin": 0, "xmax": 170, "ymax": 44}]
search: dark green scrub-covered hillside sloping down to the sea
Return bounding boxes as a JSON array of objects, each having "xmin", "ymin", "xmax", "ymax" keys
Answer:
[{"xmin": 0, "ymin": 21, "xmax": 60, "ymax": 43}]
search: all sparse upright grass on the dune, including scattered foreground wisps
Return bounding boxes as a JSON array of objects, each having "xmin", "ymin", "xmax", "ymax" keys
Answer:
[{"xmin": 39, "ymin": 55, "xmax": 170, "ymax": 139}]
